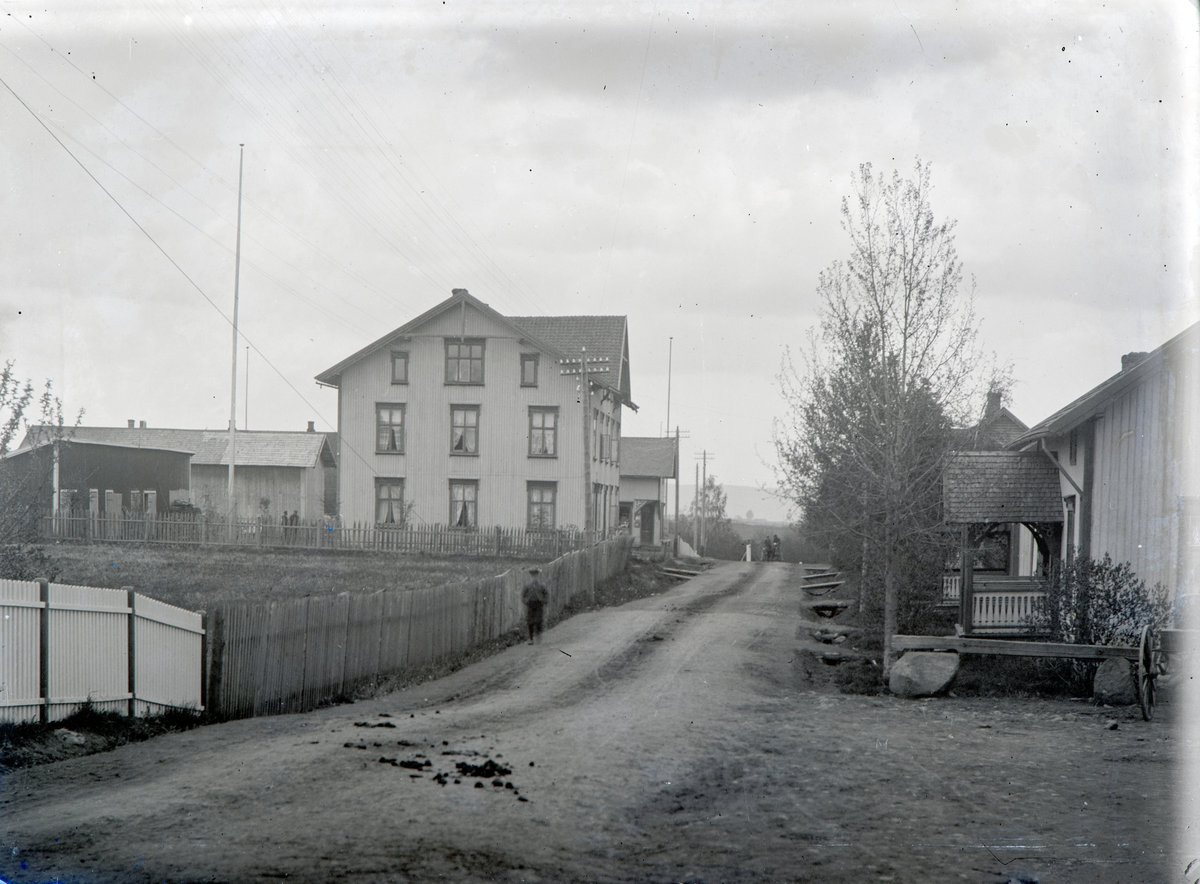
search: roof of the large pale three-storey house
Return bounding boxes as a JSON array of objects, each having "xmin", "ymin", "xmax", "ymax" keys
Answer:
[{"xmin": 317, "ymin": 289, "xmax": 637, "ymax": 410}]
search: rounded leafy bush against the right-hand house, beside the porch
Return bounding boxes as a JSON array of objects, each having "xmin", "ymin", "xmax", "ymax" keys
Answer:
[{"xmin": 1036, "ymin": 554, "xmax": 1170, "ymax": 645}]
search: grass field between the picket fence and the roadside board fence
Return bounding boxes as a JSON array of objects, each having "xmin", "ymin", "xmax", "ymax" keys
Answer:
[{"xmin": 46, "ymin": 543, "xmax": 545, "ymax": 611}]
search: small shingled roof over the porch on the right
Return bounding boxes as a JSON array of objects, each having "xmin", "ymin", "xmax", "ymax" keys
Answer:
[{"xmin": 942, "ymin": 451, "xmax": 1062, "ymax": 525}]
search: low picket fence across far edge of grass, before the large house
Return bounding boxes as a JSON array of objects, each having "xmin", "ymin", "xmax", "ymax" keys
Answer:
[{"xmin": 41, "ymin": 512, "xmax": 587, "ymax": 558}]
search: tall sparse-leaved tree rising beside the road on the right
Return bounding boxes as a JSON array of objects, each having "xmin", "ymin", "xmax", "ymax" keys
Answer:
[{"xmin": 775, "ymin": 161, "xmax": 980, "ymax": 669}]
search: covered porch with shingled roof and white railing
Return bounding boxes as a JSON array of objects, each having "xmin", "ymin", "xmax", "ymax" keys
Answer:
[{"xmin": 942, "ymin": 451, "xmax": 1063, "ymax": 636}]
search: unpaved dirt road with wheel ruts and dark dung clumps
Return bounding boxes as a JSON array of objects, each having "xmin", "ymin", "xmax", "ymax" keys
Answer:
[{"xmin": 0, "ymin": 564, "xmax": 1184, "ymax": 884}]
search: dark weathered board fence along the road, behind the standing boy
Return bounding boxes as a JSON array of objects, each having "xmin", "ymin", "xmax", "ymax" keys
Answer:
[{"xmin": 206, "ymin": 536, "xmax": 632, "ymax": 718}]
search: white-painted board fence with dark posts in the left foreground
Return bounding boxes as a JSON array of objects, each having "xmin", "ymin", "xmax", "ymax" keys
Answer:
[{"xmin": 0, "ymin": 581, "xmax": 204, "ymax": 722}]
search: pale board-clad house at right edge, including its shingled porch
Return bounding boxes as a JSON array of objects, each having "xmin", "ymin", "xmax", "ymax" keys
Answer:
[{"xmin": 944, "ymin": 323, "xmax": 1200, "ymax": 633}]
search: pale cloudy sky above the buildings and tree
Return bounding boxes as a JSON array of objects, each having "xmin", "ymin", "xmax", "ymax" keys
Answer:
[{"xmin": 0, "ymin": 0, "xmax": 1200, "ymax": 520}]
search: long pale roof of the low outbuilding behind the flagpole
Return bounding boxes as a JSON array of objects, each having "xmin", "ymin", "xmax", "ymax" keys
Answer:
[{"xmin": 22, "ymin": 427, "xmax": 336, "ymax": 468}]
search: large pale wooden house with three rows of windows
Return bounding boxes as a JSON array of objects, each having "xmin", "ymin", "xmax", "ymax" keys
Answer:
[{"xmin": 317, "ymin": 289, "xmax": 636, "ymax": 536}]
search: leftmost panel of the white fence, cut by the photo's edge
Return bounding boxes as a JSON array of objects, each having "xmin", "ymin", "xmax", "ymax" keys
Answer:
[{"xmin": 0, "ymin": 581, "xmax": 42, "ymax": 722}]
